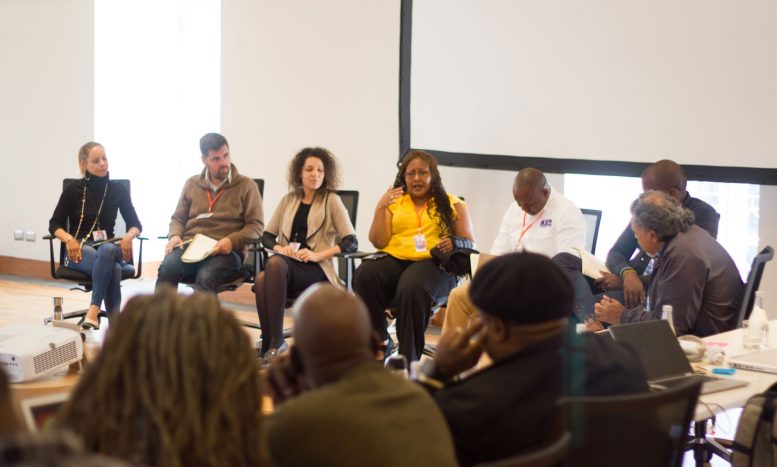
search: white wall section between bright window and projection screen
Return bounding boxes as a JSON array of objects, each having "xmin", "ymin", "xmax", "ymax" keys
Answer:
[{"xmin": 222, "ymin": 0, "xmax": 400, "ymax": 245}]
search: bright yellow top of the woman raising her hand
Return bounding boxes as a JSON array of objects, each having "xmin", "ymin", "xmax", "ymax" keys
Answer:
[{"xmin": 383, "ymin": 194, "xmax": 464, "ymax": 261}]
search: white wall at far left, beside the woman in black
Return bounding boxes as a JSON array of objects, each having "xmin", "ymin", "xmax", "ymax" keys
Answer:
[{"xmin": 0, "ymin": 0, "xmax": 94, "ymax": 259}]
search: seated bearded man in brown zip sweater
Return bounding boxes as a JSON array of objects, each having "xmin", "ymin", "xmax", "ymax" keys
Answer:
[{"xmin": 157, "ymin": 133, "xmax": 264, "ymax": 291}]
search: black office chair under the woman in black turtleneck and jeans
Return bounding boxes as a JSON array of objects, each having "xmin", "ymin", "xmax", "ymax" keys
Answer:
[{"xmin": 43, "ymin": 178, "xmax": 147, "ymax": 323}]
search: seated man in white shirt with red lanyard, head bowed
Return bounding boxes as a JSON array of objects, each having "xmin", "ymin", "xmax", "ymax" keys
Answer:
[{"xmin": 442, "ymin": 168, "xmax": 586, "ymax": 333}]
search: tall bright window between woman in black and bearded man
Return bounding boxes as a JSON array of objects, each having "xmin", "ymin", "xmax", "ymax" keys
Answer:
[{"xmin": 94, "ymin": 0, "xmax": 221, "ymax": 260}]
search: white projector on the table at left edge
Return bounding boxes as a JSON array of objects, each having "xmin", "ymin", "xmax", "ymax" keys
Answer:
[{"xmin": 0, "ymin": 324, "xmax": 84, "ymax": 383}]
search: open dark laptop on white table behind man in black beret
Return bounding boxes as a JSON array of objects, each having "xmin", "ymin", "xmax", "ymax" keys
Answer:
[{"xmin": 610, "ymin": 319, "xmax": 748, "ymax": 394}]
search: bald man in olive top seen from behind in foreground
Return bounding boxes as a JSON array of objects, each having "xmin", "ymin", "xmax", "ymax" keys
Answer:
[{"xmin": 267, "ymin": 284, "xmax": 457, "ymax": 467}]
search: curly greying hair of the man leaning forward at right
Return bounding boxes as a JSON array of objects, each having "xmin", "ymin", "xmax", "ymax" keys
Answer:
[{"xmin": 631, "ymin": 190, "xmax": 694, "ymax": 242}]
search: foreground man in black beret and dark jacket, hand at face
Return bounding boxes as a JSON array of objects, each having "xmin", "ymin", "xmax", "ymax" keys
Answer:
[{"xmin": 419, "ymin": 253, "xmax": 647, "ymax": 466}]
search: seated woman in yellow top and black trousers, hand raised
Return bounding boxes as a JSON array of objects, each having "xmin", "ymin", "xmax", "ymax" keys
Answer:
[{"xmin": 354, "ymin": 151, "xmax": 475, "ymax": 360}]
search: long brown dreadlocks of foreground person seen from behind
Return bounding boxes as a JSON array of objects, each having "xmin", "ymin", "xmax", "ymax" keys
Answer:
[{"xmin": 58, "ymin": 287, "xmax": 264, "ymax": 467}]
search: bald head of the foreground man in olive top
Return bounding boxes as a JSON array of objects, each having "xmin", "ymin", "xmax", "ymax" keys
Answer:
[{"xmin": 294, "ymin": 283, "xmax": 375, "ymax": 385}]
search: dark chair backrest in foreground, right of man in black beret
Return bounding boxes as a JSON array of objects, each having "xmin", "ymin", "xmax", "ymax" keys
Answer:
[{"xmin": 561, "ymin": 380, "xmax": 701, "ymax": 467}]
